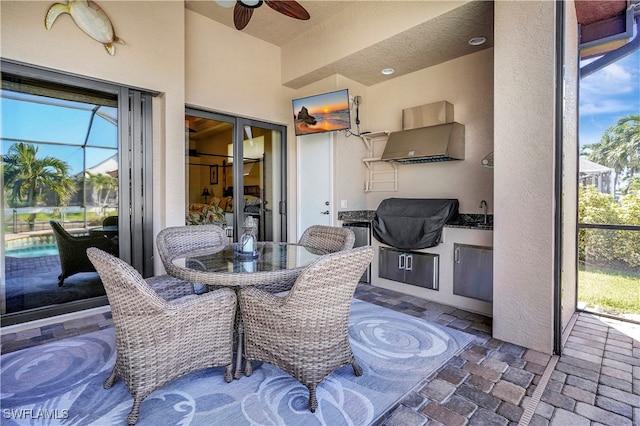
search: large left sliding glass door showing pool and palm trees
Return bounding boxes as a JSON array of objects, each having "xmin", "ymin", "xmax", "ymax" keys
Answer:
[{"xmin": 0, "ymin": 61, "xmax": 153, "ymax": 325}]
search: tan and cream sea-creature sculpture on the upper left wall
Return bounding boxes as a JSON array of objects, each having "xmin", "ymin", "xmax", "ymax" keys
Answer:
[{"xmin": 44, "ymin": 0, "xmax": 124, "ymax": 56}]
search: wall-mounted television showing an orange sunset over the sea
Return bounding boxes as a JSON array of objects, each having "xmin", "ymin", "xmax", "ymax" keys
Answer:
[{"xmin": 293, "ymin": 89, "xmax": 351, "ymax": 136}]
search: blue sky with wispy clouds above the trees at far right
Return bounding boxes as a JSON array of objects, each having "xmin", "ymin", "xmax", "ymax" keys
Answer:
[{"xmin": 579, "ymin": 47, "xmax": 640, "ymax": 146}]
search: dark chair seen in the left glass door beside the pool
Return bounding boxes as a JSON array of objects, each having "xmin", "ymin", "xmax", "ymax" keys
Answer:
[{"xmin": 49, "ymin": 220, "xmax": 113, "ymax": 287}]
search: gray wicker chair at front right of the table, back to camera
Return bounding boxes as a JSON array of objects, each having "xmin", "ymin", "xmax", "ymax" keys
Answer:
[{"xmin": 239, "ymin": 246, "xmax": 374, "ymax": 412}]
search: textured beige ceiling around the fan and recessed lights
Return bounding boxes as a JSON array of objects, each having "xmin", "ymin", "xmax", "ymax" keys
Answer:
[{"xmin": 185, "ymin": 0, "xmax": 493, "ymax": 89}]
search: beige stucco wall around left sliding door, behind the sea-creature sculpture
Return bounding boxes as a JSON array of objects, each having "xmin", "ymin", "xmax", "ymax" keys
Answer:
[{"xmin": 0, "ymin": 1, "xmax": 185, "ymax": 267}]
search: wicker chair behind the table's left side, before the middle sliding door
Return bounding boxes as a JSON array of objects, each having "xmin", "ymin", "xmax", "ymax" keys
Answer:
[{"xmin": 153, "ymin": 225, "xmax": 229, "ymax": 292}]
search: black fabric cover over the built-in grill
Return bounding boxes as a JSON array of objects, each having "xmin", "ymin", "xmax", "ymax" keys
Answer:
[{"xmin": 372, "ymin": 198, "xmax": 459, "ymax": 250}]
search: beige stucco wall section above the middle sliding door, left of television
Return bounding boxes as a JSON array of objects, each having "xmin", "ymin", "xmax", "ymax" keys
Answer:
[{"xmin": 184, "ymin": 10, "xmax": 295, "ymax": 125}]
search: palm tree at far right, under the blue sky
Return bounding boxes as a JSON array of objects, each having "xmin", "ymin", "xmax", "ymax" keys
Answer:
[{"xmin": 581, "ymin": 114, "xmax": 640, "ymax": 192}]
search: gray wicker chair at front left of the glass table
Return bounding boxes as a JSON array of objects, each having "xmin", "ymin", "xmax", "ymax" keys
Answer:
[{"xmin": 87, "ymin": 248, "xmax": 237, "ymax": 424}]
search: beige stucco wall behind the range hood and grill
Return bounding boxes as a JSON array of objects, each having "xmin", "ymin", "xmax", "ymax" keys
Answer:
[{"xmin": 363, "ymin": 49, "xmax": 494, "ymax": 214}]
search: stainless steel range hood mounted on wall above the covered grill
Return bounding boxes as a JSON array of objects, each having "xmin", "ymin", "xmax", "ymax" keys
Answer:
[{"xmin": 381, "ymin": 101, "xmax": 464, "ymax": 164}]
